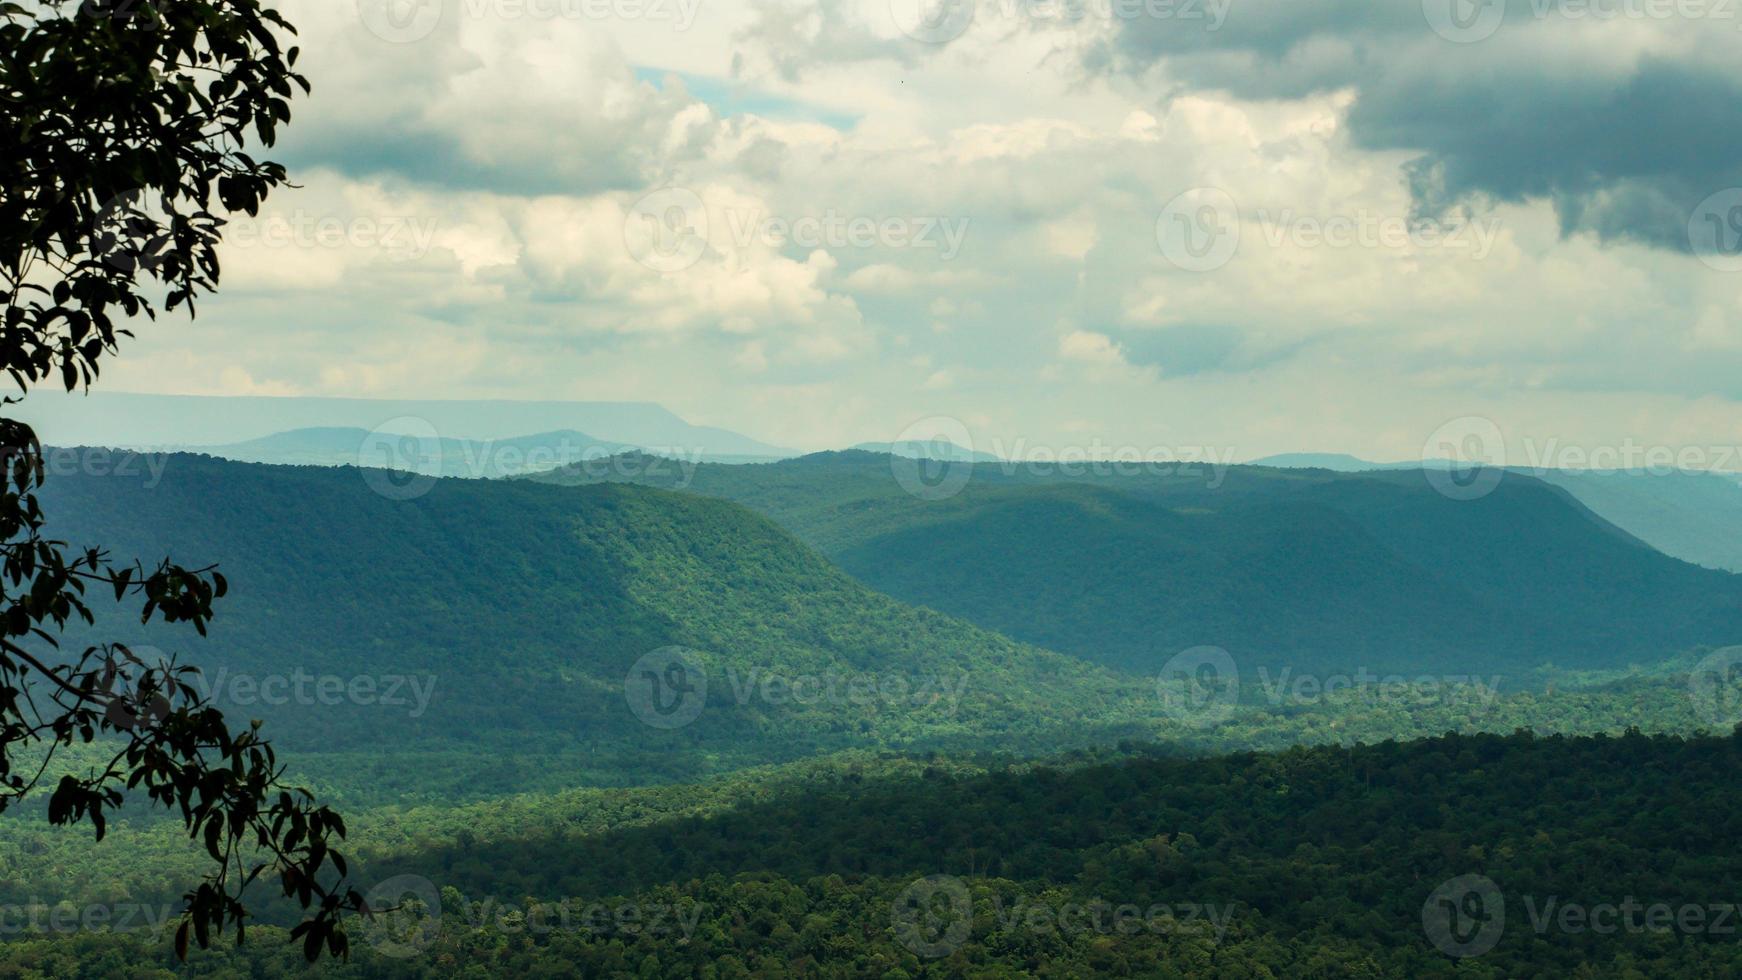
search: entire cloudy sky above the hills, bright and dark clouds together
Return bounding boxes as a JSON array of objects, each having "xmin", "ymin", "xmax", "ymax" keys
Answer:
[{"xmin": 71, "ymin": 0, "xmax": 1742, "ymax": 468}]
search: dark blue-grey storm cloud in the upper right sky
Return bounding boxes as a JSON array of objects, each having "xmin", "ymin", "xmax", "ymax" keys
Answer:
[{"xmin": 1087, "ymin": 0, "xmax": 1742, "ymax": 251}]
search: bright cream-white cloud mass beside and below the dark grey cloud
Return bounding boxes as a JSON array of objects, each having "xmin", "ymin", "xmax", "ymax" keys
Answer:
[{"xmin": 67, "ymin": 0, "xmax": 1742, "ymax": 454}]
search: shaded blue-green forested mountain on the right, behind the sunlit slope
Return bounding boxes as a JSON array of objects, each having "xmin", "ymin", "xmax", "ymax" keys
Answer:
[{"xmin": 531, "ymin": 451, "xmax": 1742, "ymax": 672}]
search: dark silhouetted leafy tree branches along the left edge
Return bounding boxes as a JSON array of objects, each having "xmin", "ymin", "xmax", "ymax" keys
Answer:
[{"xmin": 0, "ymin": 0, "xmax": 368, "ymax": 959}]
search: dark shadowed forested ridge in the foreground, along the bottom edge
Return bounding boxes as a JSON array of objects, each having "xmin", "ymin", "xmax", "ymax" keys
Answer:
[{"xmin": 0, "ymin": 733, "xmax": 1742, "ymax": 978}]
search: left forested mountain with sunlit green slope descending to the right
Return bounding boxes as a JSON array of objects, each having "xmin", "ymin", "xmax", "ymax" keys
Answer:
[{"xmin": 44, "ymin": 454, "xmax": 1135, "ymax": 775}]
